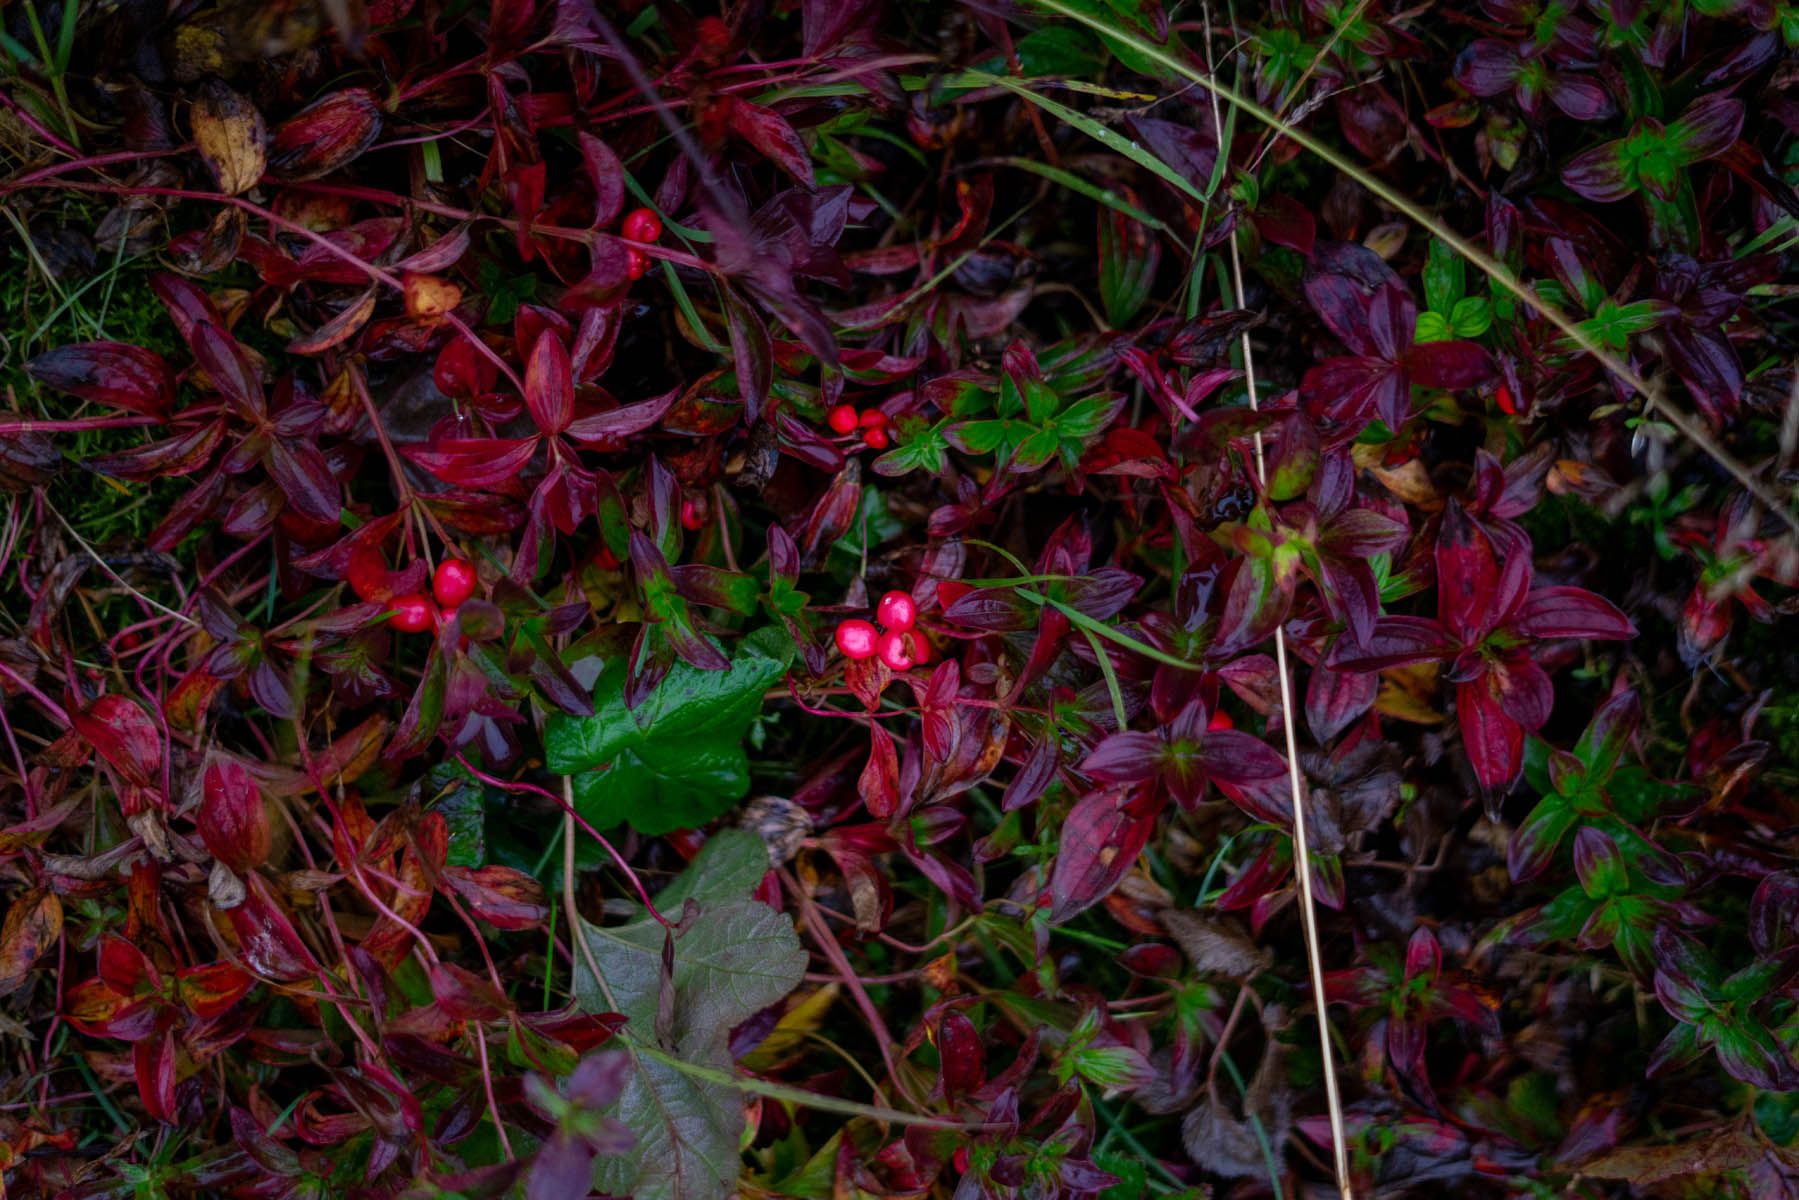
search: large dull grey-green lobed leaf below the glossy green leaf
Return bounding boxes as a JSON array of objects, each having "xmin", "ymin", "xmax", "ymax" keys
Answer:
[{"xmin": 574, "ymin": 829, "xmax": 806, "ymax": 1200}]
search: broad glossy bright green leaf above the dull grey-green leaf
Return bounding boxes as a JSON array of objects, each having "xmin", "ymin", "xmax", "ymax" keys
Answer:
[{"xmin": 543, "ymin": 631, "xmax": 786, "ymax": 833}]
